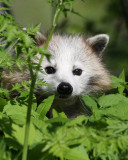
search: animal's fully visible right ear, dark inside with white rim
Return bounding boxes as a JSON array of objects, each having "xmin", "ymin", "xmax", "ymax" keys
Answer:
[{"xmin": 86, "ymin": 34, "xmax": 109, "ymax": 54}]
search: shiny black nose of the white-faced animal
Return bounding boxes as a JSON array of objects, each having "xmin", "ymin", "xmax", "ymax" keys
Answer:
[{"xmin": 57, "ymin": 82, "xmax": 73, "ymax": 95}]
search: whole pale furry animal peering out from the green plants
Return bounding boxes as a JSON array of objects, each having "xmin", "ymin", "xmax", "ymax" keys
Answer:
[{"xmin": 2, "ymin": 34, "xmax": 111, "ymax": 119}]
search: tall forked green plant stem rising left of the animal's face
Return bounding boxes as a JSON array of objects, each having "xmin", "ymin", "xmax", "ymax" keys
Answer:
[{"xmin": 22, "ymin": 2, "xmax": 61, "ymax": 160}]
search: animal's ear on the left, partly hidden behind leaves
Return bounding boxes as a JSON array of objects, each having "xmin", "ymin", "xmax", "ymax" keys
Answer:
[{"xmin": 23, "ymin": 28, "xmax": 47, "ymax": 47}]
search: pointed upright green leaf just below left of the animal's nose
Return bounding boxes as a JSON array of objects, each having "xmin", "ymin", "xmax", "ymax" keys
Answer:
[{"xmin": 37, "ymin": 95, "xmax": 54, "ymax": 120}]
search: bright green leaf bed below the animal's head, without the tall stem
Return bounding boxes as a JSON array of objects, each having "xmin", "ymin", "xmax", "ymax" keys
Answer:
[{"xmin": 0, "ymin": 74, "xmax": 128, "ymax": 160}]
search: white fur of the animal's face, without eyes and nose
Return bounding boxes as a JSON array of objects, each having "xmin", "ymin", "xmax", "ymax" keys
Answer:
[{"xmin": 38, "ymin": 35, "xmax": 108, "ymax": 97}]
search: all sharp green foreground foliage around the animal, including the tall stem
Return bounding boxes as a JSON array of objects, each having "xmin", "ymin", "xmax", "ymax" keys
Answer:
[{"xmin": 0, "ymin": 0, "xmax": 128, "ymax": 160}]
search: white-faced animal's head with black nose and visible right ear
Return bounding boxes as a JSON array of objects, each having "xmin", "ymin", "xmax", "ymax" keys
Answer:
[{"xmin": 35, "ymin": 34, "xmax": 110, "ymax": 98}]
